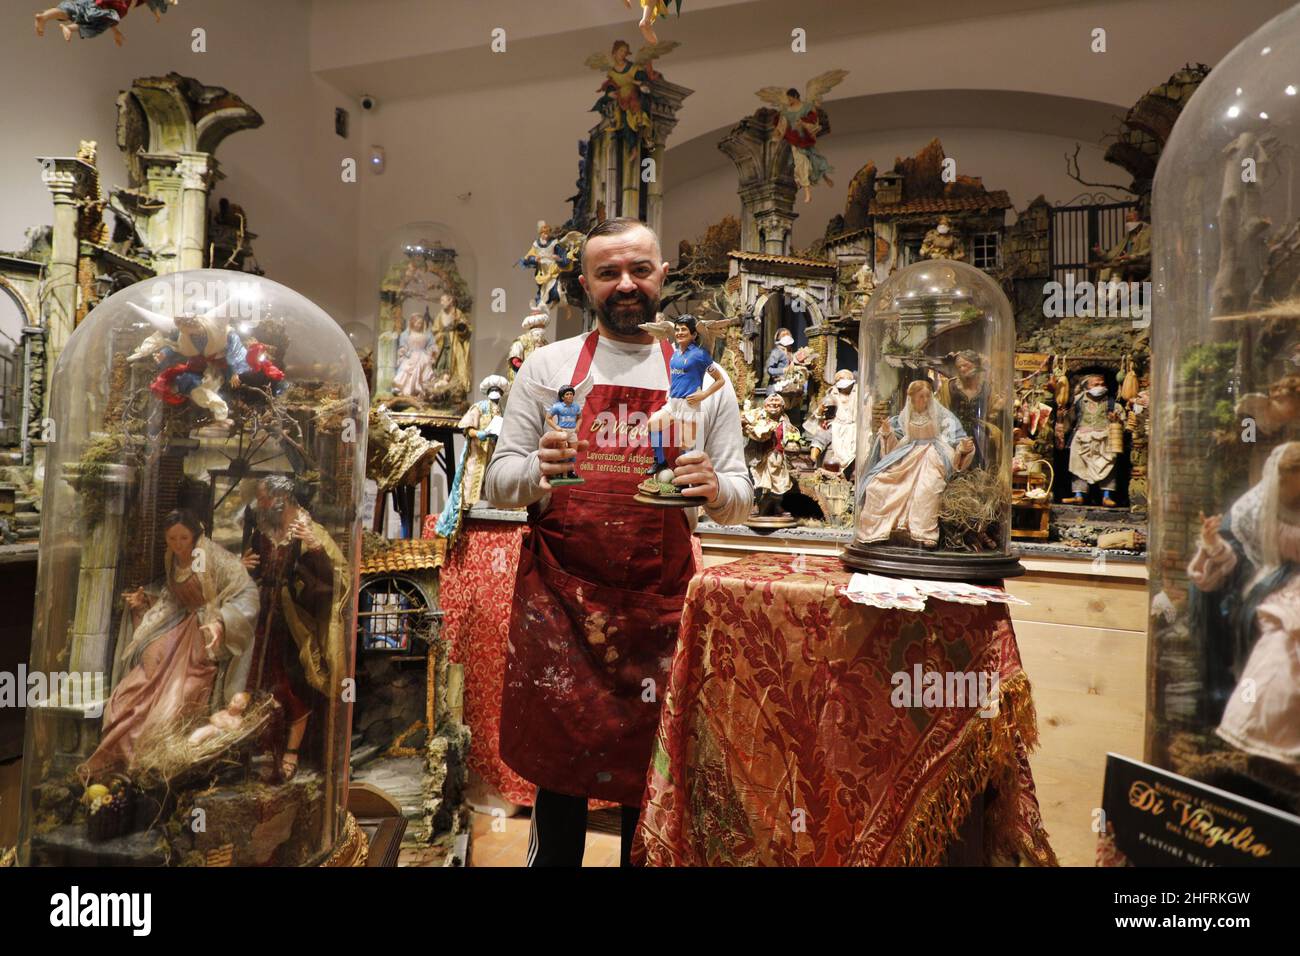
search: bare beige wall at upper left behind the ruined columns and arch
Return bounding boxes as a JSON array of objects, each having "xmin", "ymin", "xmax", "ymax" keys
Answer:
[{"xmin": 0, "ymin": 0, "xmax": 361, "ymax": 323}]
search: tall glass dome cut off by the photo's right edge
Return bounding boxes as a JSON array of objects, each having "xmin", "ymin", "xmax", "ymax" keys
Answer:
[{"xmin": 1147, "ymin": 7, "xmax": 1300, "ymax": 813}]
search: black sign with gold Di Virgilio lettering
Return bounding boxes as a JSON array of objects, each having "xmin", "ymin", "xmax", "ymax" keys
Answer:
[{"xmin": 1095, "ymin": 753, "xmax": 1300, "ymax": 866}]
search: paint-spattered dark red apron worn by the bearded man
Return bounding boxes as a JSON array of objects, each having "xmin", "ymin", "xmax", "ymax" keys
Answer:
[{"xmin": 501, "ymin": 332, "xmax": 696, "ymax": 805}]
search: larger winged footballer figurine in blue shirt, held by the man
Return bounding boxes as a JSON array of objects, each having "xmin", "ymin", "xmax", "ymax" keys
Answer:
[{"xmin": 637, "ymin": 315, "xmax": 729, "ymax": 506}]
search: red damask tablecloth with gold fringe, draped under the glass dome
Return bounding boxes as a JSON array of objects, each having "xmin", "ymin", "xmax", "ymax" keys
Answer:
[{"xmin": 638, "ymin": 554, "xmax": 1056, "ymax": 866}]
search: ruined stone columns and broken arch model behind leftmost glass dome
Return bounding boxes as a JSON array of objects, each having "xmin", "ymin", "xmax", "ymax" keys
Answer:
[{"xmin": 0, "ymin": 73, "xmax": 263, "ymax": 463}]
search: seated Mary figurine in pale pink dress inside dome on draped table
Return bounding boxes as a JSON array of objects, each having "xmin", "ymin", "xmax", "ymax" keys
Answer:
[{"xmin": 858, "ymin": 378, "xmax": 975, "ymax": 548}]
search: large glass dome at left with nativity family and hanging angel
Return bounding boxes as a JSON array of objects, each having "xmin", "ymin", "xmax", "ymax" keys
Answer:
[{"xmin": 20, "ymin": 271, "xmax": 369, "ymax": 866}]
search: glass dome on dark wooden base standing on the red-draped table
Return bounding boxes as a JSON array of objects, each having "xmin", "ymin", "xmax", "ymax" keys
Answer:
[{"xmin": 841, "ymin": 259, "xmax": 1022, "ymax": 580}]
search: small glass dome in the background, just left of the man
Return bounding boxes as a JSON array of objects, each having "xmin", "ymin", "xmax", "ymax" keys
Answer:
[{"xmin": 374, "ymin": 222, "xmax": 477, "ymax": 425}]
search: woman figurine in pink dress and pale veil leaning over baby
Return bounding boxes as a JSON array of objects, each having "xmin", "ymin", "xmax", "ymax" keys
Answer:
[{"xmin": 78, "ymin": 511, "xmax": 257, "ymax": 780}]
